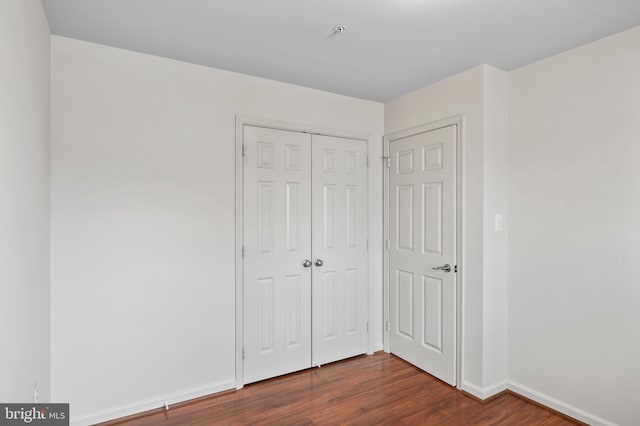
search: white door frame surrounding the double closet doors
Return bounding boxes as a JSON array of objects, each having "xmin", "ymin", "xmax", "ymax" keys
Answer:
[{"xmin": 235, "ymin": 115, "xmax": 375, "ymax": 389}]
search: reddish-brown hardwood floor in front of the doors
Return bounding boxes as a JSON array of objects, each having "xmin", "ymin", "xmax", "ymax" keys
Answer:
[{"xmin": 105, "ymin": 352, "xmax": 578, "ymax": 425}]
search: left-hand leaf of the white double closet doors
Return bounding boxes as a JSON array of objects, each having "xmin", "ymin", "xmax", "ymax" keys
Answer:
[{"xmin": 244, "ymin": 126, "xmax": 311, "ymax": 383}]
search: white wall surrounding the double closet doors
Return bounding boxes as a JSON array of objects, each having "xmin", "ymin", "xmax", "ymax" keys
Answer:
[{"xmin": 51, "ymin": 37, "xmax": 383, "ymax": 423}]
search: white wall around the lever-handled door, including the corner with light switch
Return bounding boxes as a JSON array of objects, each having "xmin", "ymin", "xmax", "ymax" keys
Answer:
[{"xmin": 385, "ymin": 66, "xmax": 507, "ymax": 398}]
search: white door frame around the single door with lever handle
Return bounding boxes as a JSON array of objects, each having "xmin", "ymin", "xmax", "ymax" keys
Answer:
[{"xmin": 382, "ymin": 115, "xmax": 464, "ymax": 389}]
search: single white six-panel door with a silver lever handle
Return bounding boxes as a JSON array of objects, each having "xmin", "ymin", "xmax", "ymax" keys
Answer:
[{"xmin": 389, "ymin": 125, "xmax": 457, "ymax": 385}]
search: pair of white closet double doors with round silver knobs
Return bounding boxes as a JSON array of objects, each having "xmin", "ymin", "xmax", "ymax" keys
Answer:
[{"xmin": 243, "ymin": 126, "xmax": 368, "ymax": 384}]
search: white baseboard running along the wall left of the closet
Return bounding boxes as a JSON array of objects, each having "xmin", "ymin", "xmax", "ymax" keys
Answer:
[{"xmin": 69, "ymin": 380, "xmax": 236, "ymax": 426}]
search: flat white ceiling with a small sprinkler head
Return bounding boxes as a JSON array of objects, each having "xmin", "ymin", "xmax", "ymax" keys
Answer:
[{"xmin": 42, "ymin": 0, "xmax": 640, "ymax": 101}]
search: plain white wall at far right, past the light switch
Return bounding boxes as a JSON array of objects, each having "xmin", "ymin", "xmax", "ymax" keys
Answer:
[{"xmin": 508, "ymin": 28, "xmax": 640, "ymax": 425}]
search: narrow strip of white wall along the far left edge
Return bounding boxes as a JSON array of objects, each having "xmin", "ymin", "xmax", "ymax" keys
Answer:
[{"xmin": 0, "ymin": 0, "xmax": 50, "ymax": 402}]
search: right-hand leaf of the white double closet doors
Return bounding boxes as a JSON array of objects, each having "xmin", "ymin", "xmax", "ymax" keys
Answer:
[{"xmin": 312, "ymin": 135, "xmax": 368, "ymax": 365}]
